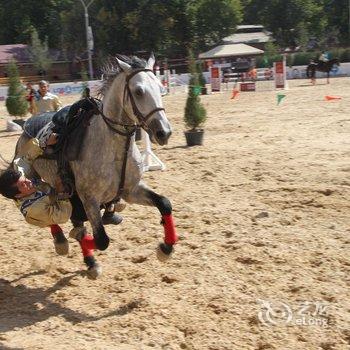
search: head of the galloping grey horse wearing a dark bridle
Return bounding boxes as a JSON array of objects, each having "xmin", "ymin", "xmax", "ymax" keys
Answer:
[{"xmin": 116, "ymin": 54, "xmax": 171, "ymax": 145}]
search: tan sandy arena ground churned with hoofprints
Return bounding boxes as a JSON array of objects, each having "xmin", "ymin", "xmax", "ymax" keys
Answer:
[{"xmin": 0, "ymin": 78, "xmax": 350, "ymax": 350}]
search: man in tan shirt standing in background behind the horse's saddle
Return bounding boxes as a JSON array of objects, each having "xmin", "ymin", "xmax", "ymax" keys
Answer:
[{"xmin": 30, "ymin": 80, "xmax": 62, "ymax": 115}]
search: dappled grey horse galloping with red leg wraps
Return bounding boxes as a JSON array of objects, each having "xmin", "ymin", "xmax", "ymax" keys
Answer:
[{"xmin": 16, "ymin": 55, "xmax": 177, "ymax": 276}]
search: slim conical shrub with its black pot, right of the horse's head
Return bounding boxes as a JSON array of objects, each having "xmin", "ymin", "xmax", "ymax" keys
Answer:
[{"xmin": 184, "ymin": 54, "xmax": 207, "ymax": 146}]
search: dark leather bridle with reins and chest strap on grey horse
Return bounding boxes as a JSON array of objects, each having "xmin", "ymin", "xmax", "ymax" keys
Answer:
[{"xmin": 89, "ymin": 68, "xmax": 165, "ymax": 203}]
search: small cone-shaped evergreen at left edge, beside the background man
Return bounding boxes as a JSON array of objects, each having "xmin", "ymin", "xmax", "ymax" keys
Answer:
[{"xmin": 6, "ymin": 60, "xmax": 28, "ymax": 117}]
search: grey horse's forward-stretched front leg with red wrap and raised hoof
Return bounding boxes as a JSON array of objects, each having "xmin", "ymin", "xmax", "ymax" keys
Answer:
[{"xmin": 124, "ymin": 183, "xmax": 178, "ymax": 261}]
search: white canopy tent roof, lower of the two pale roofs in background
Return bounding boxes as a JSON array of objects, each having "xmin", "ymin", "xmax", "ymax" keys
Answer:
[{"xmin": 199, "ymin": 44, "xmax": 264, "ymax": 59}]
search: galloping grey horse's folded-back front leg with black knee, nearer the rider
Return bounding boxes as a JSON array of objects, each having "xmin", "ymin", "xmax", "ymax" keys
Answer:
[{"xmin": 79, "ymin": 194, "xmax": 109, "ymax": 250}]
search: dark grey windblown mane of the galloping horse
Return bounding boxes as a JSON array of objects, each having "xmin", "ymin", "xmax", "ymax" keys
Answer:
[{"xmin": 98, "ymin": 55, "xmax": 147, "ymax": 97}]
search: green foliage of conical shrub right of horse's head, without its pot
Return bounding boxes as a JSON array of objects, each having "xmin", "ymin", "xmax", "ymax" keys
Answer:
[{"xmin": 184, "ymin": 54, "xmax": 207, "ymax": 131}]
